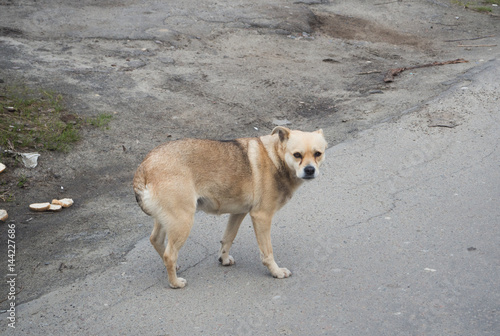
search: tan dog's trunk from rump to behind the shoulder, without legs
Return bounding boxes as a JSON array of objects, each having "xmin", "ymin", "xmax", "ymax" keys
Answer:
[{"xmin": 134, "ymin": 138, "xmax": 258, "ymax": 215}]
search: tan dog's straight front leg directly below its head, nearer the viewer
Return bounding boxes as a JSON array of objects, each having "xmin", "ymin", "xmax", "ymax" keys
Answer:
[{"xmin": 250, "ymin": 212, "xmax": 292, "ymax": 279}]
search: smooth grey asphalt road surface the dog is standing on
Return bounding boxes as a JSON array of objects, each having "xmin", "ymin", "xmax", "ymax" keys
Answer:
[{"xmin": 0, "ymin": 60, "xmax": 500, "ymax": 335}]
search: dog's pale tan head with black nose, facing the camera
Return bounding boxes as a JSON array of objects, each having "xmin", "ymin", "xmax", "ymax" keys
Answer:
[{"xmin": 271, "ymin": 126, "xmax": 327, "ymax": 180}]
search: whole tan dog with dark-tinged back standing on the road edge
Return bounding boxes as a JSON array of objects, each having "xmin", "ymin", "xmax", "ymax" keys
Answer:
[{"xmin": 134, "ymin": 127, "xmax": 327, "ymax": 288}]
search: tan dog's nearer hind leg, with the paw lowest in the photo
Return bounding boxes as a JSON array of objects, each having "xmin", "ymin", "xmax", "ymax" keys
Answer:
[{"xmin": 163, "ymin": 211, "xmax": 194, "ymax": 288}]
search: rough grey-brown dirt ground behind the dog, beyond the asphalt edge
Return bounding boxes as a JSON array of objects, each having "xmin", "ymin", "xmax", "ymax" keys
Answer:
[{"xmin": 0, "ymin": 0, "xmax": 500, "ymax": 309}]
